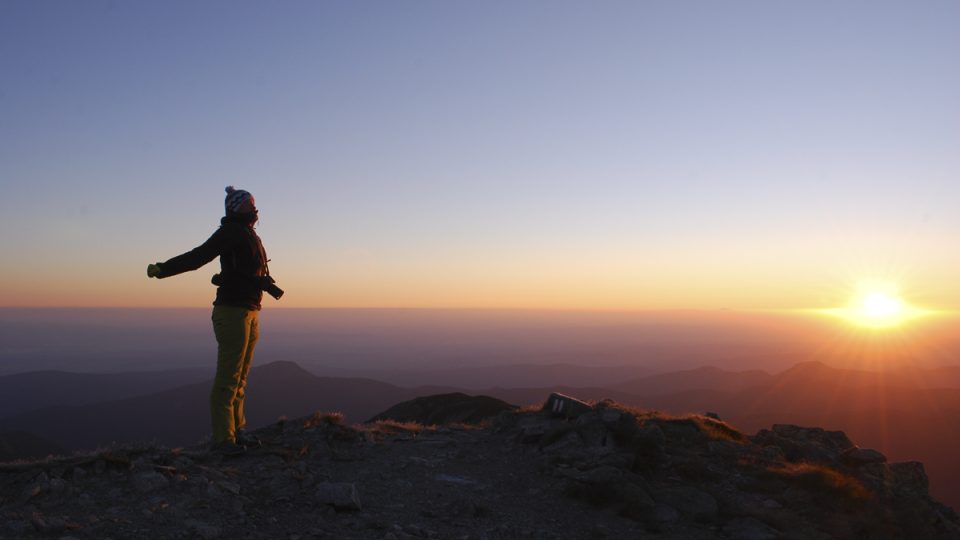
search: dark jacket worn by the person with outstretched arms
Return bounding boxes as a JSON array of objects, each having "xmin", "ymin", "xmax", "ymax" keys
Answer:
[{"xmin": 157, "ymin": 215, "xmax": 267, "ymax": 309}]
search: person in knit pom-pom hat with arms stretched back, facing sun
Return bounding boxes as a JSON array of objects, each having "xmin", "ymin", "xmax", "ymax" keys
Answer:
[{"xmin": 147, "ymin": 186, "xmax": 283, "ymax": 453}]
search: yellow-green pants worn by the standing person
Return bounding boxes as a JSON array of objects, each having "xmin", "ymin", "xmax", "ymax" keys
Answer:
[{"xmin": 210, "ymin": 306, "xmax": 260, "ymax": 443}]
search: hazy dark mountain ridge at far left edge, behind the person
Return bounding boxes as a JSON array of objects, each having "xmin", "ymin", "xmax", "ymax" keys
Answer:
[{"xmin": 0, "ymin": 369, "xmax": 213, "ymax": 417}]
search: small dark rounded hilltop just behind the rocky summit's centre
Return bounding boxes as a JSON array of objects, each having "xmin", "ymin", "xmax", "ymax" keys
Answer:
[{"xmin": 368, "ymin": 392, "xmax": 517, "ymax": 426}]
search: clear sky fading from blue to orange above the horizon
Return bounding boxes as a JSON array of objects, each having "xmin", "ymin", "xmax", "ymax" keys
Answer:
[{"xmin": 0, "ymin": 0, "xmax": 960, "ymax": 309}]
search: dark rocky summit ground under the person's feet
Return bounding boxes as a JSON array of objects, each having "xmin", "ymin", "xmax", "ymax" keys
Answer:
[{"xmin": 0, "ymin": 396, "xmax": 960, "ymax": 540}]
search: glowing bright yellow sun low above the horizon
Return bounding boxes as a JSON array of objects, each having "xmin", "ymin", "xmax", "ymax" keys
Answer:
[{"xmin": 824, "ymin": 281, "xmax": 927, "ymax": 329}]
